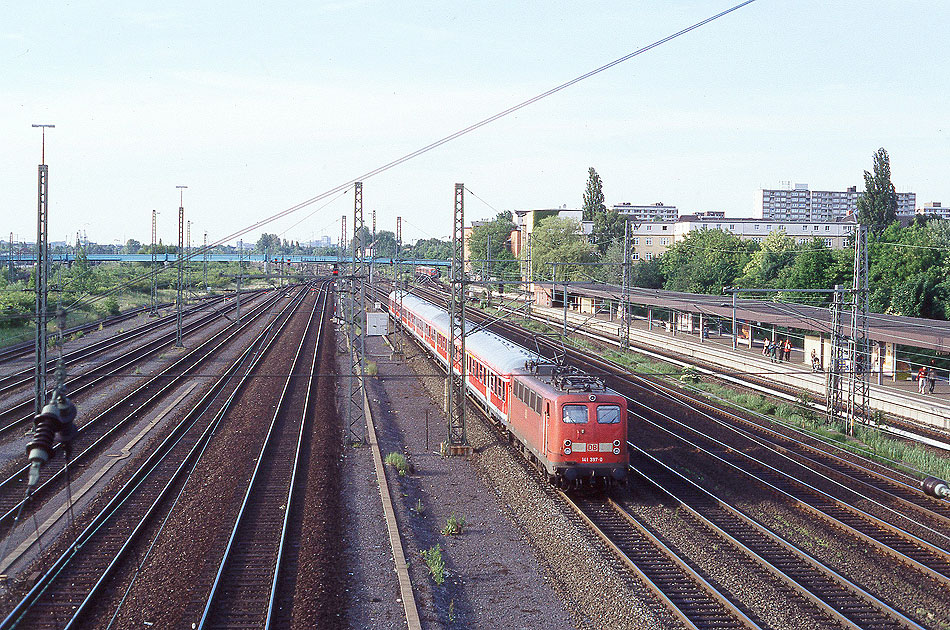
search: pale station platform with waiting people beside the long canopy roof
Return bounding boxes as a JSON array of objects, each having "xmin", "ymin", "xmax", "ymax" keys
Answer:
[{"xmin": 531, "ymin": 305, "xmax": 950, "ymax": 431}]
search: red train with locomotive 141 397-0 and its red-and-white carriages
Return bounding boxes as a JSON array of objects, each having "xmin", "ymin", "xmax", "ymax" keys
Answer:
[{"xmin": 389, "ymin": 291, "xmax": 627, "ymax": 486}]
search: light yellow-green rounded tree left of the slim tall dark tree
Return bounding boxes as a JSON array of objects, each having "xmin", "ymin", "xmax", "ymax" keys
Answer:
[{"xmin": 531, "ymin": 217, "xmax": 596, "ymax": 280}]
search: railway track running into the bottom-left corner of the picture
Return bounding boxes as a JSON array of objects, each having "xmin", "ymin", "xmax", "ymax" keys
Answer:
[{"xmin": 0, "ymin": 290, "xmax": 307, "ymax": 628}]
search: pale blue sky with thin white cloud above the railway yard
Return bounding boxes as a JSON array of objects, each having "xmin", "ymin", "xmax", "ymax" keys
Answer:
[{"xmin": 0, "ymin": 0, "xmax": 950, "ymax": 249}]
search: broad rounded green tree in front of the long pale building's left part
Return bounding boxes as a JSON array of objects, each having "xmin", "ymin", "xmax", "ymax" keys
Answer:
[{"xmin": 660, "ymin": 230, "xmax": 758, "ymax": 294}]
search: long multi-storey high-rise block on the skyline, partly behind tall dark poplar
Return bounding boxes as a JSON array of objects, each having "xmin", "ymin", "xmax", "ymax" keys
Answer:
[{"xmin": 755, "ymin": 184, "xmax": 917, "ymax": 221}]
